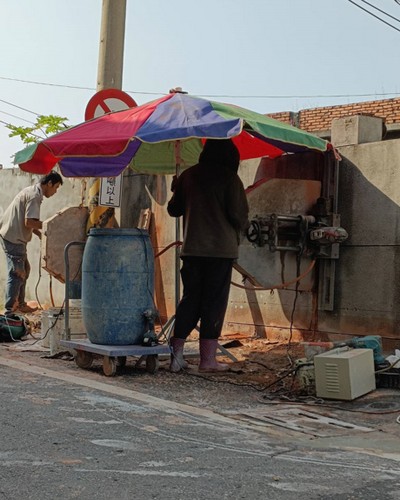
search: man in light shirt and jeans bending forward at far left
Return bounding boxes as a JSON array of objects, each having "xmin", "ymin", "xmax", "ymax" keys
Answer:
[{"xmin": 0, "ymin": 171, "xmax": 63, "ymax": 315}]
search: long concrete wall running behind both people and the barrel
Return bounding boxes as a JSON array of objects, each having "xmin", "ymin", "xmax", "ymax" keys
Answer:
[{"xmin": 0, "ymin": 140, "xmax": 400, "ymax": 344}]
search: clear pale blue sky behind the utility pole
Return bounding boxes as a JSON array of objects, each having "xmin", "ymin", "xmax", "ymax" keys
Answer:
[{"xmin": 0, "ymin": 0, "xmax": 400, "ymax": 167}]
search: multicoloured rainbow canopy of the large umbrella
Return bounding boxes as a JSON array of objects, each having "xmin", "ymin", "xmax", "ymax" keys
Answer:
[{"xmin": 14, "ymin": 93, "xmax": 331, "ymax": 177}]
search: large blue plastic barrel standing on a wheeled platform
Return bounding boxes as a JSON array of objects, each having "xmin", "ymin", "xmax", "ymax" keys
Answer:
[{"xmin": 82, "ymin": 228, "xmax": 154, "ymax": 345}]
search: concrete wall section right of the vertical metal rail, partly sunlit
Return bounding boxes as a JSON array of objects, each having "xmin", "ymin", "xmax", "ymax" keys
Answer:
[{"xmin": 319, "ymin": 140, "xmax": 400, "ymax": 339}]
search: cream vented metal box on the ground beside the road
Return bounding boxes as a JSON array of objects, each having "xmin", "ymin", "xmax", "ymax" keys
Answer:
[{"xmin": 314, "ymin": 349, "xmax": 376, "ymax": 400}]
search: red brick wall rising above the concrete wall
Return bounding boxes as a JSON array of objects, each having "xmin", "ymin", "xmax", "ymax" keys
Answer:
[{"xmin": 268, "ymin": 97, "xmax": 400, "ymax": 132}]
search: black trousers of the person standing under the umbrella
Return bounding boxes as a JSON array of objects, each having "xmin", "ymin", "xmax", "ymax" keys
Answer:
[{"xmin": 174, "ymin": 257, "xmax": 233, "ymax": 339}]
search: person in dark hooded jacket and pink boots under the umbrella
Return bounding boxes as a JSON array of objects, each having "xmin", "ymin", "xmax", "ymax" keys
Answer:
[{"xmin": 168, "ymin": 139, "xmax": 248, "ymax": 372}]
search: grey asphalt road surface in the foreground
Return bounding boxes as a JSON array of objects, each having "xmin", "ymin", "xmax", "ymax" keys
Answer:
[{"xmin": 0, "ymin": 356, "xmax": 400, "ymax": 500}]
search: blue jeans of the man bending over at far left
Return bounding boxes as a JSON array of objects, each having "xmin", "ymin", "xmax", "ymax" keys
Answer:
[{"xmin": 0, "ymin": 237, "xmax": 31, "ymax": 314}]
